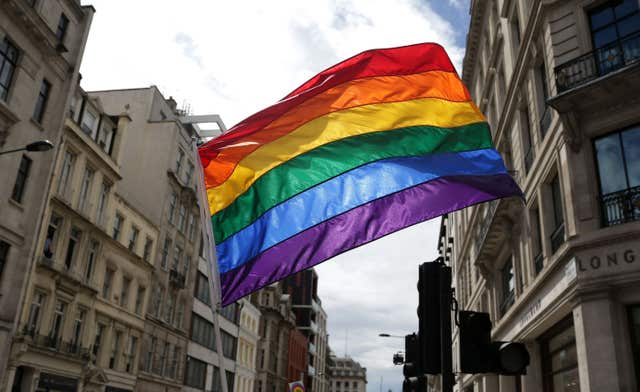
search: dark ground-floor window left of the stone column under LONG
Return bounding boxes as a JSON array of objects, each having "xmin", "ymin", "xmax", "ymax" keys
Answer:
[{"xmin": 540, "ymin": 317, "xmax": 580, "ymax": 392}]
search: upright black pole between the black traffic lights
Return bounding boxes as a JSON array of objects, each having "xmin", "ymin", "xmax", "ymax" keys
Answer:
[{"xmin": 440, "ymin": 265, "xmax": 454, "ymax": 392}]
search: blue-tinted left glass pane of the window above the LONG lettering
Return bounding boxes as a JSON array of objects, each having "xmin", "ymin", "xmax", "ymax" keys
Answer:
[{"xmin": 595, "ymin": 133, "xmax": 627, "ymax": 195}]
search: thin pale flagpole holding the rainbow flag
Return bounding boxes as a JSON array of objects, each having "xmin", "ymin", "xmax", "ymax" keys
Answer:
[{"xmin": 191, "ymin": 136, "xmax": 233, "ymax": 392}]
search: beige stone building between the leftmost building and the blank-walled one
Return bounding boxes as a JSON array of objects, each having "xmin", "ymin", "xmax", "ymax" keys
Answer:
[{"xmin": 5, "ymin": 88, "xmax": 158, "ymax": 391}]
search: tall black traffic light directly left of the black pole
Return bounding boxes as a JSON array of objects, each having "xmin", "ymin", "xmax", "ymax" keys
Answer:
[{"xmin": 418, "ymin": 262, "xmax": 442, "ymax": 374}]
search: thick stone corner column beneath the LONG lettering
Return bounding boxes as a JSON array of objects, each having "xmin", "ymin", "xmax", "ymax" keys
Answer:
[{"xmin": 573, "ymin": 298, "xmax": 620, "ymax": 392}]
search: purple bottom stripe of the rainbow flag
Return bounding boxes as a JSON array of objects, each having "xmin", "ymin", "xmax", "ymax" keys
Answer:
[{"xmin": 220, "ymin": 174, "xmax": 522, "ymax": 305}]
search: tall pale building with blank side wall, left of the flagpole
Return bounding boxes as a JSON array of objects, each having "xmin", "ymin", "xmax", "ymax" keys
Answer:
[{"xmin": 89, "ymin": 86, "xmax": 211, "ymax": 391}]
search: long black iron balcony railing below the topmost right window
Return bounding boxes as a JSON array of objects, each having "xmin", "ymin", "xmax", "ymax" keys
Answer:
[{"xmin": 555, "ymin": 31, "xmax": 640, "ymax": 93}]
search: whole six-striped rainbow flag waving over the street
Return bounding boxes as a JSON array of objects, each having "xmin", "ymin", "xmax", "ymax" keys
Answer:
[{"xmin": 199, "ymin": 43, "xmax": 522, "ymax": 305}]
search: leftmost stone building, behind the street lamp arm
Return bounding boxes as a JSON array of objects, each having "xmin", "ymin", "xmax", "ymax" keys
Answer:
[{"xmin": 0, "ymin": 0, "xmax": 94, "ymax": 389}]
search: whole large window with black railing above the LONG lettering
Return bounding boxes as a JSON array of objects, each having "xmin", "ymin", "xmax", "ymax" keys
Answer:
[{"xmin": 594, "ymin": 125, "xmax": 640, "ymax": 226}]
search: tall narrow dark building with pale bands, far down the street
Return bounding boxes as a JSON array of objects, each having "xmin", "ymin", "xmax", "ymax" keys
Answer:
[{"xmin": 282, "ymin": 269, "xmax": 329, "ymax": 392}]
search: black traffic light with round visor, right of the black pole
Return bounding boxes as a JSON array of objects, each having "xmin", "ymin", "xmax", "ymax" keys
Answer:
[{"xmin": 459, "ymin": 310, "xmax": 529, "ymax": 375}]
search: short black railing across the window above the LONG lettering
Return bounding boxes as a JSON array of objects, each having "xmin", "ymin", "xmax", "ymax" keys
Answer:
[{"xmin": 600, "ymin": 186, "xmax": 640, "ymax": 226}]
